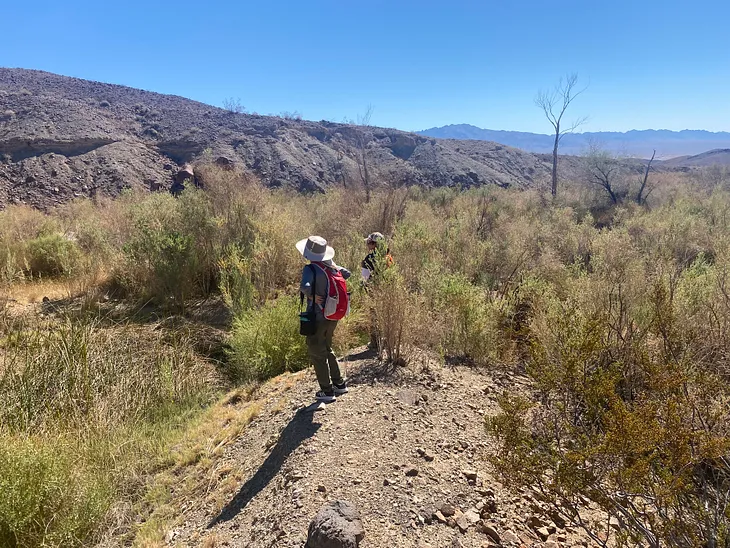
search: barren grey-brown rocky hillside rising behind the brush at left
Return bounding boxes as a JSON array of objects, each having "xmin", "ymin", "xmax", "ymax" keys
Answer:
[{"xmin": 0, "ymin": 68, "xmax": 549, "ymax": 208}]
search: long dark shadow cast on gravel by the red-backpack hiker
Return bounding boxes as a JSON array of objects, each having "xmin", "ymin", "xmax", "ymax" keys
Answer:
[{"xmin": 208, "ymin": 409, "xmax": 322, "ymax": 529}]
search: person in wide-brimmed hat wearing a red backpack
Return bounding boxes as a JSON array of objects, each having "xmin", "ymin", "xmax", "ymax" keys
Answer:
[{"xmin": 296, "ymin": 236, "xmax": 351, "ymax": 403}]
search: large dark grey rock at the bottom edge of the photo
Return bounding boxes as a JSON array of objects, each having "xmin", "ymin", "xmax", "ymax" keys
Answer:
[{"xmin": 305, "ymin": 500, "xmax": 365, "ymax": 548}]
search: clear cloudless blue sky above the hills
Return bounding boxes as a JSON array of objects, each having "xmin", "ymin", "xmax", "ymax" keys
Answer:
[{"xmin": 0, "ymin": 0, "xmax": 730, "ymax": 133}]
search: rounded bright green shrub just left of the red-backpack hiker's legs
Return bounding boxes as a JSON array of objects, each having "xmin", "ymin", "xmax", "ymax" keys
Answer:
[{"xmin": 229, "ymin": 297, "xmax": 309, "ymax": 382}]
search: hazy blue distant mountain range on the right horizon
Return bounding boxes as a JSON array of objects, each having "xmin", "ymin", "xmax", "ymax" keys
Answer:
[{"xmin": 417, "ymin": 124, "xmax": 730, "ymax": 159}]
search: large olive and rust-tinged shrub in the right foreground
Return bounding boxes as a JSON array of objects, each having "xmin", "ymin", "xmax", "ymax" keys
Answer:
[{"xmin": 489, "ymin": 262, "xmax": 730, "ymax": 546}]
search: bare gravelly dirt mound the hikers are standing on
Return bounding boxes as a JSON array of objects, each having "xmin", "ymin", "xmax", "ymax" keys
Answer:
[{"xmin": 167, "ymin": 354, "xmax": 582, "ymax": 548}]
